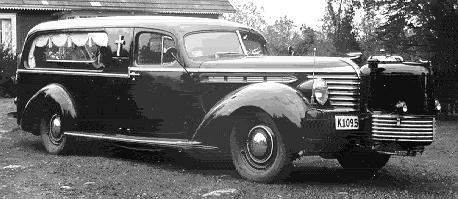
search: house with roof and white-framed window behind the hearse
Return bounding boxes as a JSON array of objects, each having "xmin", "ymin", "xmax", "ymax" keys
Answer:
[{"xmin": 0, "ymin": 0, "xmax": 235, "ymax": 53}]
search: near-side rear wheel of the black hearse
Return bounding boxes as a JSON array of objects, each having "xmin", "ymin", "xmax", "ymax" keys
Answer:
[{"xmin": 40, "ymin": 111, "xmax": 68, "ymax": 154}]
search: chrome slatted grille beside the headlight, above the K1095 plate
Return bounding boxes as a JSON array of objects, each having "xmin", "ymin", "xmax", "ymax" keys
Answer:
[{"xmin": 315, "ymin": 73, "xmax": 360, "ymax": 112}]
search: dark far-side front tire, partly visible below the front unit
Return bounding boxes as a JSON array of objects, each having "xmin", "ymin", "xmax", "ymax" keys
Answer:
[{"xmin": 337, "ymin": 152, "xmax": 390, "ymax": 172}]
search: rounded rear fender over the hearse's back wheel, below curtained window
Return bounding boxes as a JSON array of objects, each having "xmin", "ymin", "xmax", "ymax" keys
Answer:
[{"xmin": 20, "ymin": 84, "xmax": 77, "ymax": 134}]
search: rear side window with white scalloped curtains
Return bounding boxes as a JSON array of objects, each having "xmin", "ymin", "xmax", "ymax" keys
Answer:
[{"xmin": 27, "ymin": 32, "xmax": 108, "ymax": 70}]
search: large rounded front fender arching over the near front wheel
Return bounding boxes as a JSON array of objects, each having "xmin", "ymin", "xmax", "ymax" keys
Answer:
[{"xmin": 193, "ymin": 82, "xmax": 310, "ymax": 154}]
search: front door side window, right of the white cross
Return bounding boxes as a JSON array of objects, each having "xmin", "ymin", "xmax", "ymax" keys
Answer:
[{"xmin": 137, "ymin": 33, "xmax": 175, "ymax": 65}]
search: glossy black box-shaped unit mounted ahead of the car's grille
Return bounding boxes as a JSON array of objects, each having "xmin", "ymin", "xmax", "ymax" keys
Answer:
[{"xmin": 361, "ymin": 63, "xmax": 436, "ymax": 115}]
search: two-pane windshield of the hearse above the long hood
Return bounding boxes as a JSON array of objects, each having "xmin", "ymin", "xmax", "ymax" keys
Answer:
[{"xmin": 185, "ymin": 32, "xmax": 267, "ymax": 60}]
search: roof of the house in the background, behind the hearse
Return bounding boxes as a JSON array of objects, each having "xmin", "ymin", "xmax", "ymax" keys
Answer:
[{"xmin": 0, "ymin": 0, "xmax": 235, "ymax": 14}]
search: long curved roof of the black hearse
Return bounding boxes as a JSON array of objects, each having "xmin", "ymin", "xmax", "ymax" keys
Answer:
[{"xmin": 29, "ymin": 16, "xmax": 252, "ymax": 35}]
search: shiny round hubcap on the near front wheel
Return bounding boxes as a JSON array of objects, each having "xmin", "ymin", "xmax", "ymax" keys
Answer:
[{"xmin": 247, "ymin": 125, "xmax": 274, "ymax": 164}]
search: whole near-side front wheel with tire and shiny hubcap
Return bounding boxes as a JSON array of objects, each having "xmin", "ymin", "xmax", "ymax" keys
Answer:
[{"xmin": 230, "ymin": 114, "xmax": 292, "ymax": 183}]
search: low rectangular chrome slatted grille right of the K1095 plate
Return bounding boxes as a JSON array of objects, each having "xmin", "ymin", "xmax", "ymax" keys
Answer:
[{"xmin": 372, "ymin": 115, "xmax": 435, "ymax": 142}]
